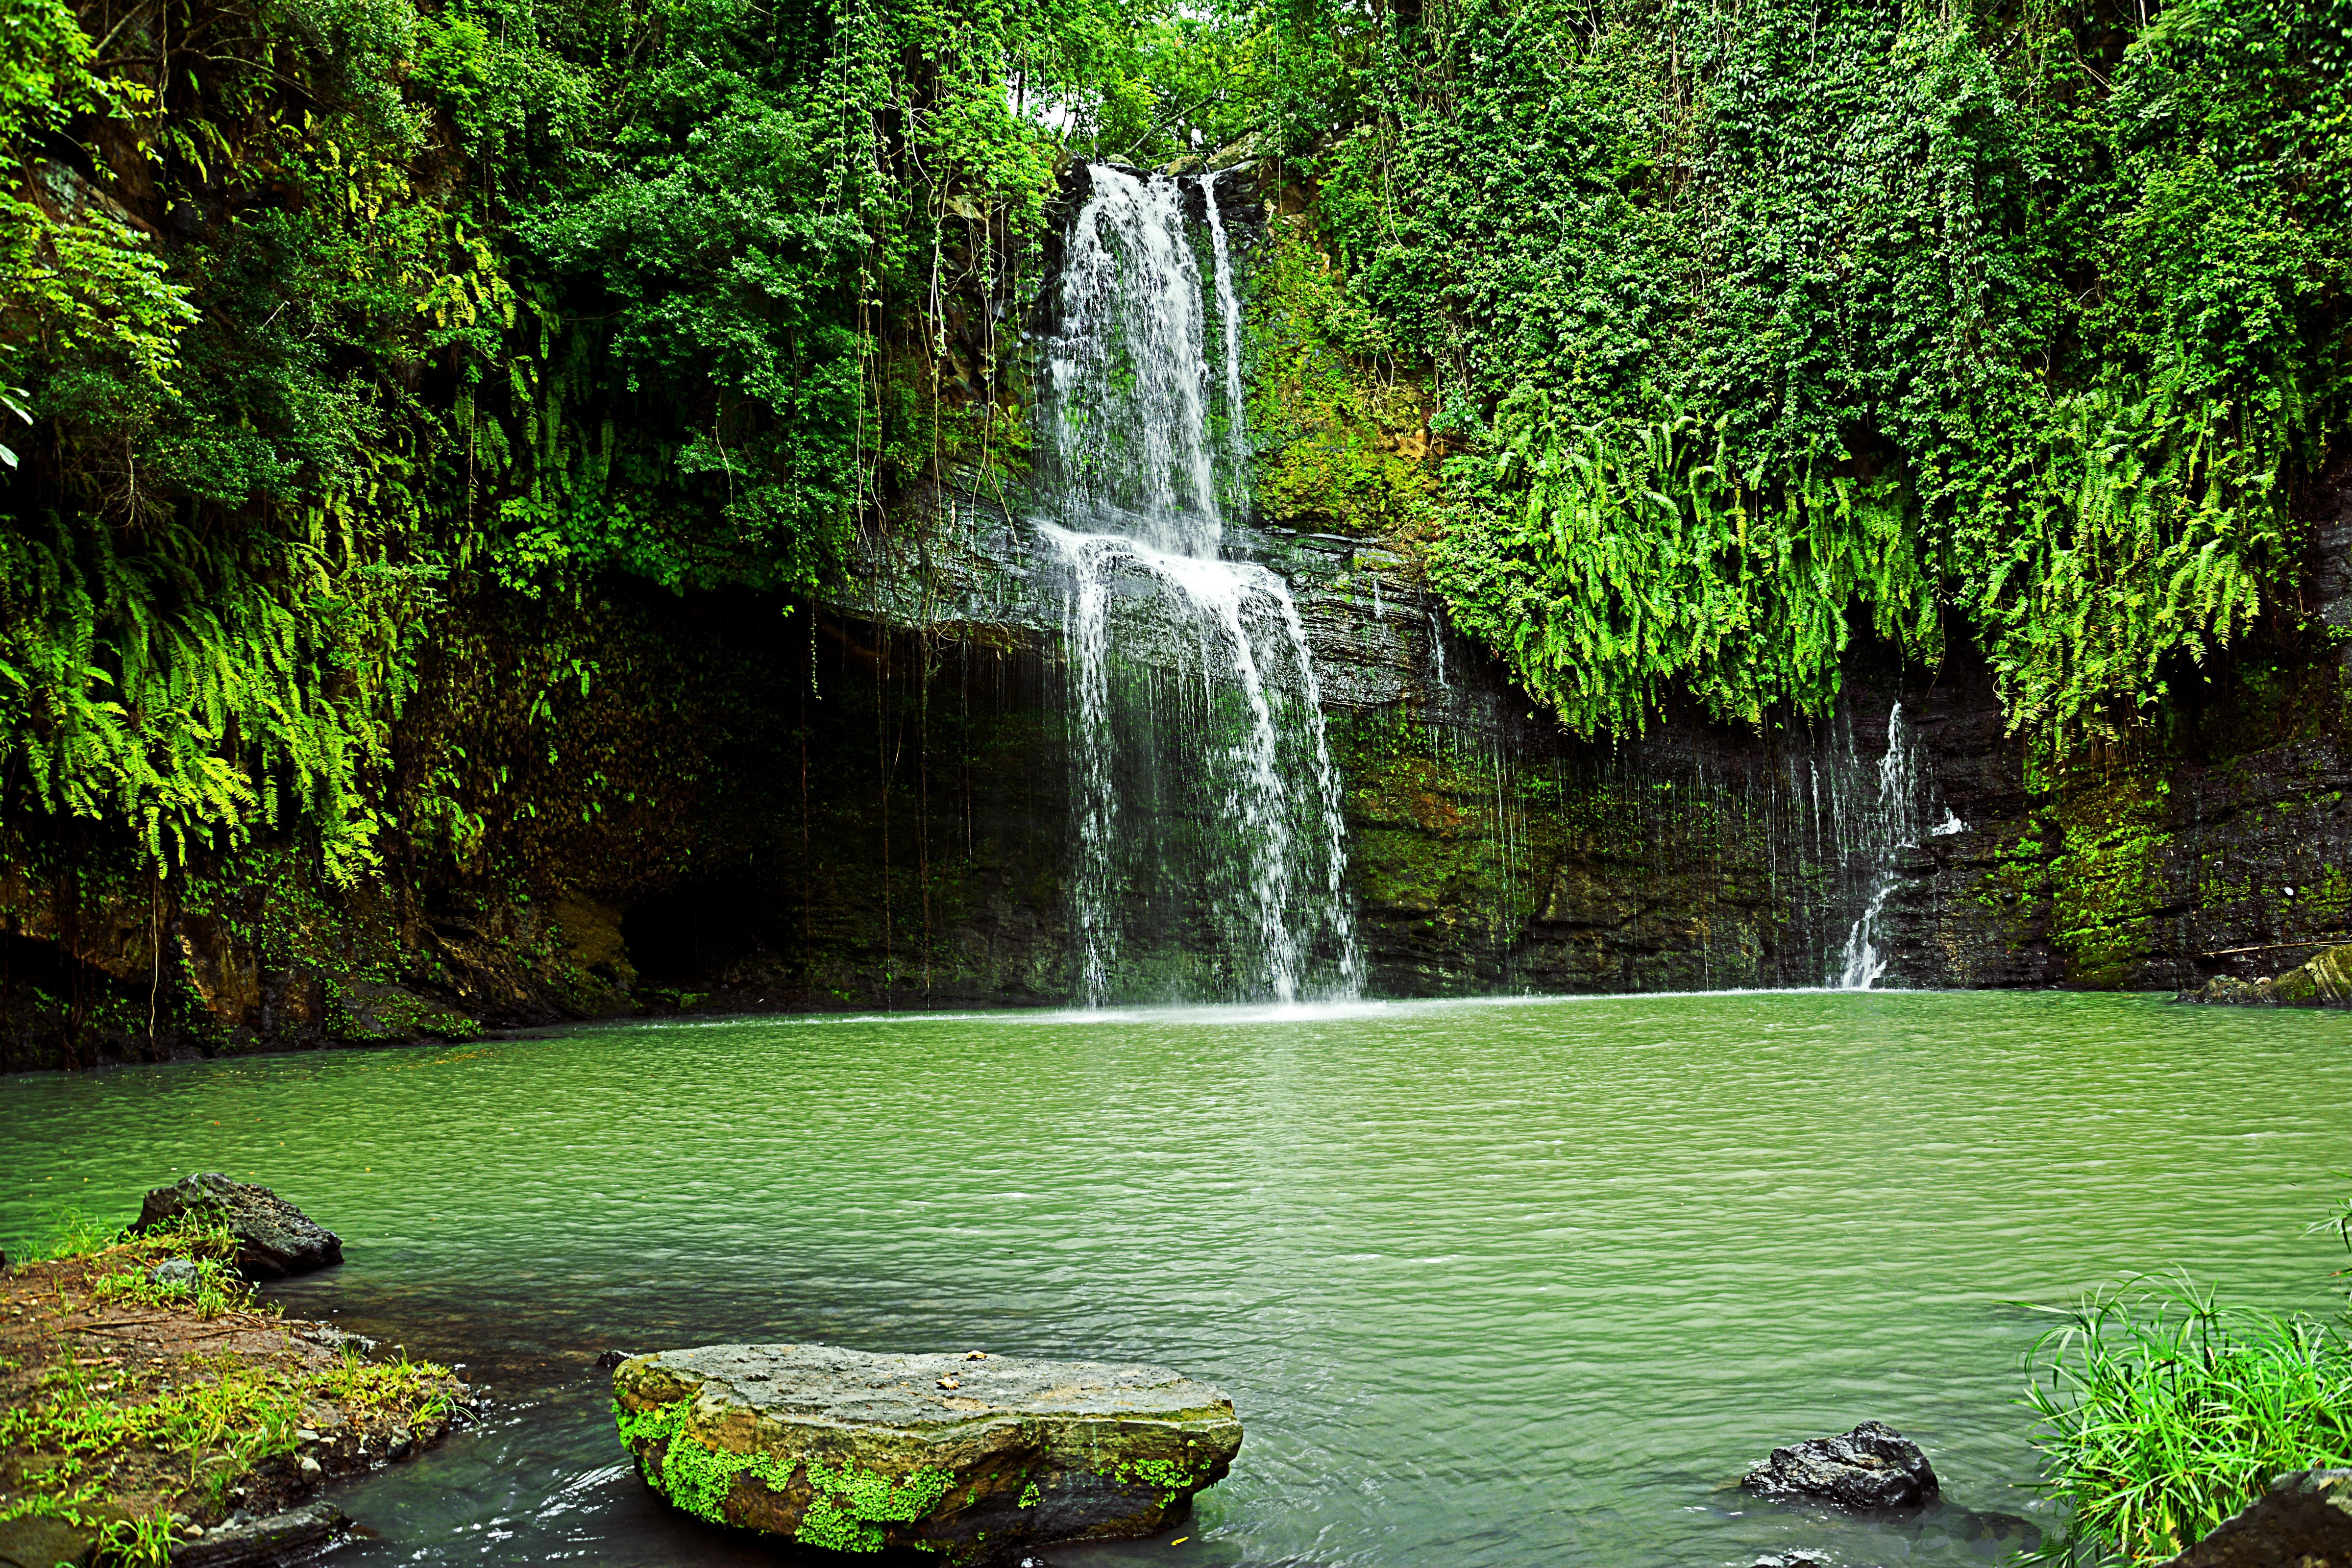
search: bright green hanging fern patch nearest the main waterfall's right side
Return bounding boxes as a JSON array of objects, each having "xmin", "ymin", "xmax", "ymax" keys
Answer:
[{"xmin": 1430, "ymin": 394, "xmax": 1938, "ymax": 731}]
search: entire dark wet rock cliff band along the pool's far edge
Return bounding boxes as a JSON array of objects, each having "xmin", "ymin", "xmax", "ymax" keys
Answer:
[{"xmin": 0, "ymin": 172, "xmax": 2352, "ymax": 1070}]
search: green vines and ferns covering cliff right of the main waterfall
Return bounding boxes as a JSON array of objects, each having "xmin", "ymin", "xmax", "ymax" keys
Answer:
[{"xmin": 1223, "ymin": 0, "xmax": 2352, "ymax": 743}]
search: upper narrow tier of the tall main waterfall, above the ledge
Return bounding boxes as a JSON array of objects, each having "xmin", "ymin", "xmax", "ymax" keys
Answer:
[{"xmin": 1040, "ymin": 165, "xmax": 1242, "ymax": 557}]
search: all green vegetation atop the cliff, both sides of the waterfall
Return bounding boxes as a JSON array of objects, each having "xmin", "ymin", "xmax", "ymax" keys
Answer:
[{"xmin": 0, "ymin": 0, "xmax": 2352, "ymax": 879}]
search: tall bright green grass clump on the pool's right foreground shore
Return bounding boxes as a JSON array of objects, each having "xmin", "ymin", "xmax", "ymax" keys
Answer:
[{"xmin": 2025, "ymin": 1276, "xmax": 2352, "ymax": 1566}]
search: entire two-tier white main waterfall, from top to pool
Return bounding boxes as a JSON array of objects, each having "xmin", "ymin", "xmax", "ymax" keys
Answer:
[{"xmin": 1037, "ymin": 165, "xmax": 1362, "ymax": 1004}]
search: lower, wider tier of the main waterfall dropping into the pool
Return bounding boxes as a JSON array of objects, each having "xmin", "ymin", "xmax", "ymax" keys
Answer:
[{"xmin": 1040, "ymin": 527, "xmax": 1362, "ymax": 1004}]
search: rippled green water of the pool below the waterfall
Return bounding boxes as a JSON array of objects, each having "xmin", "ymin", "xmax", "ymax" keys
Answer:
[{"xmin": 0, "ymin": 992, "xmax": 2352, "ymax": 1568}]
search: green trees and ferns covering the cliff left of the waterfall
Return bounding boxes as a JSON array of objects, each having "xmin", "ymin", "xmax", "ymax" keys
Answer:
[{"xmin": 0, "ymin": 0, "xmax": 1148, "ymax": 884}]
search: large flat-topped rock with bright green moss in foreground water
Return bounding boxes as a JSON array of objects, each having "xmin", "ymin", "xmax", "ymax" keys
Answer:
[{"xmin": 612, "ymin": 1345, "xmax": 1242, "ymax": 1563}]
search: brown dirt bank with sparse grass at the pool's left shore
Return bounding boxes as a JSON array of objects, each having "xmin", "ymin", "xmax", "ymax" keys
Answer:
[{"xmin": 0, "ymin": 1227, "xmax": 473, "ymax": 1568}]
